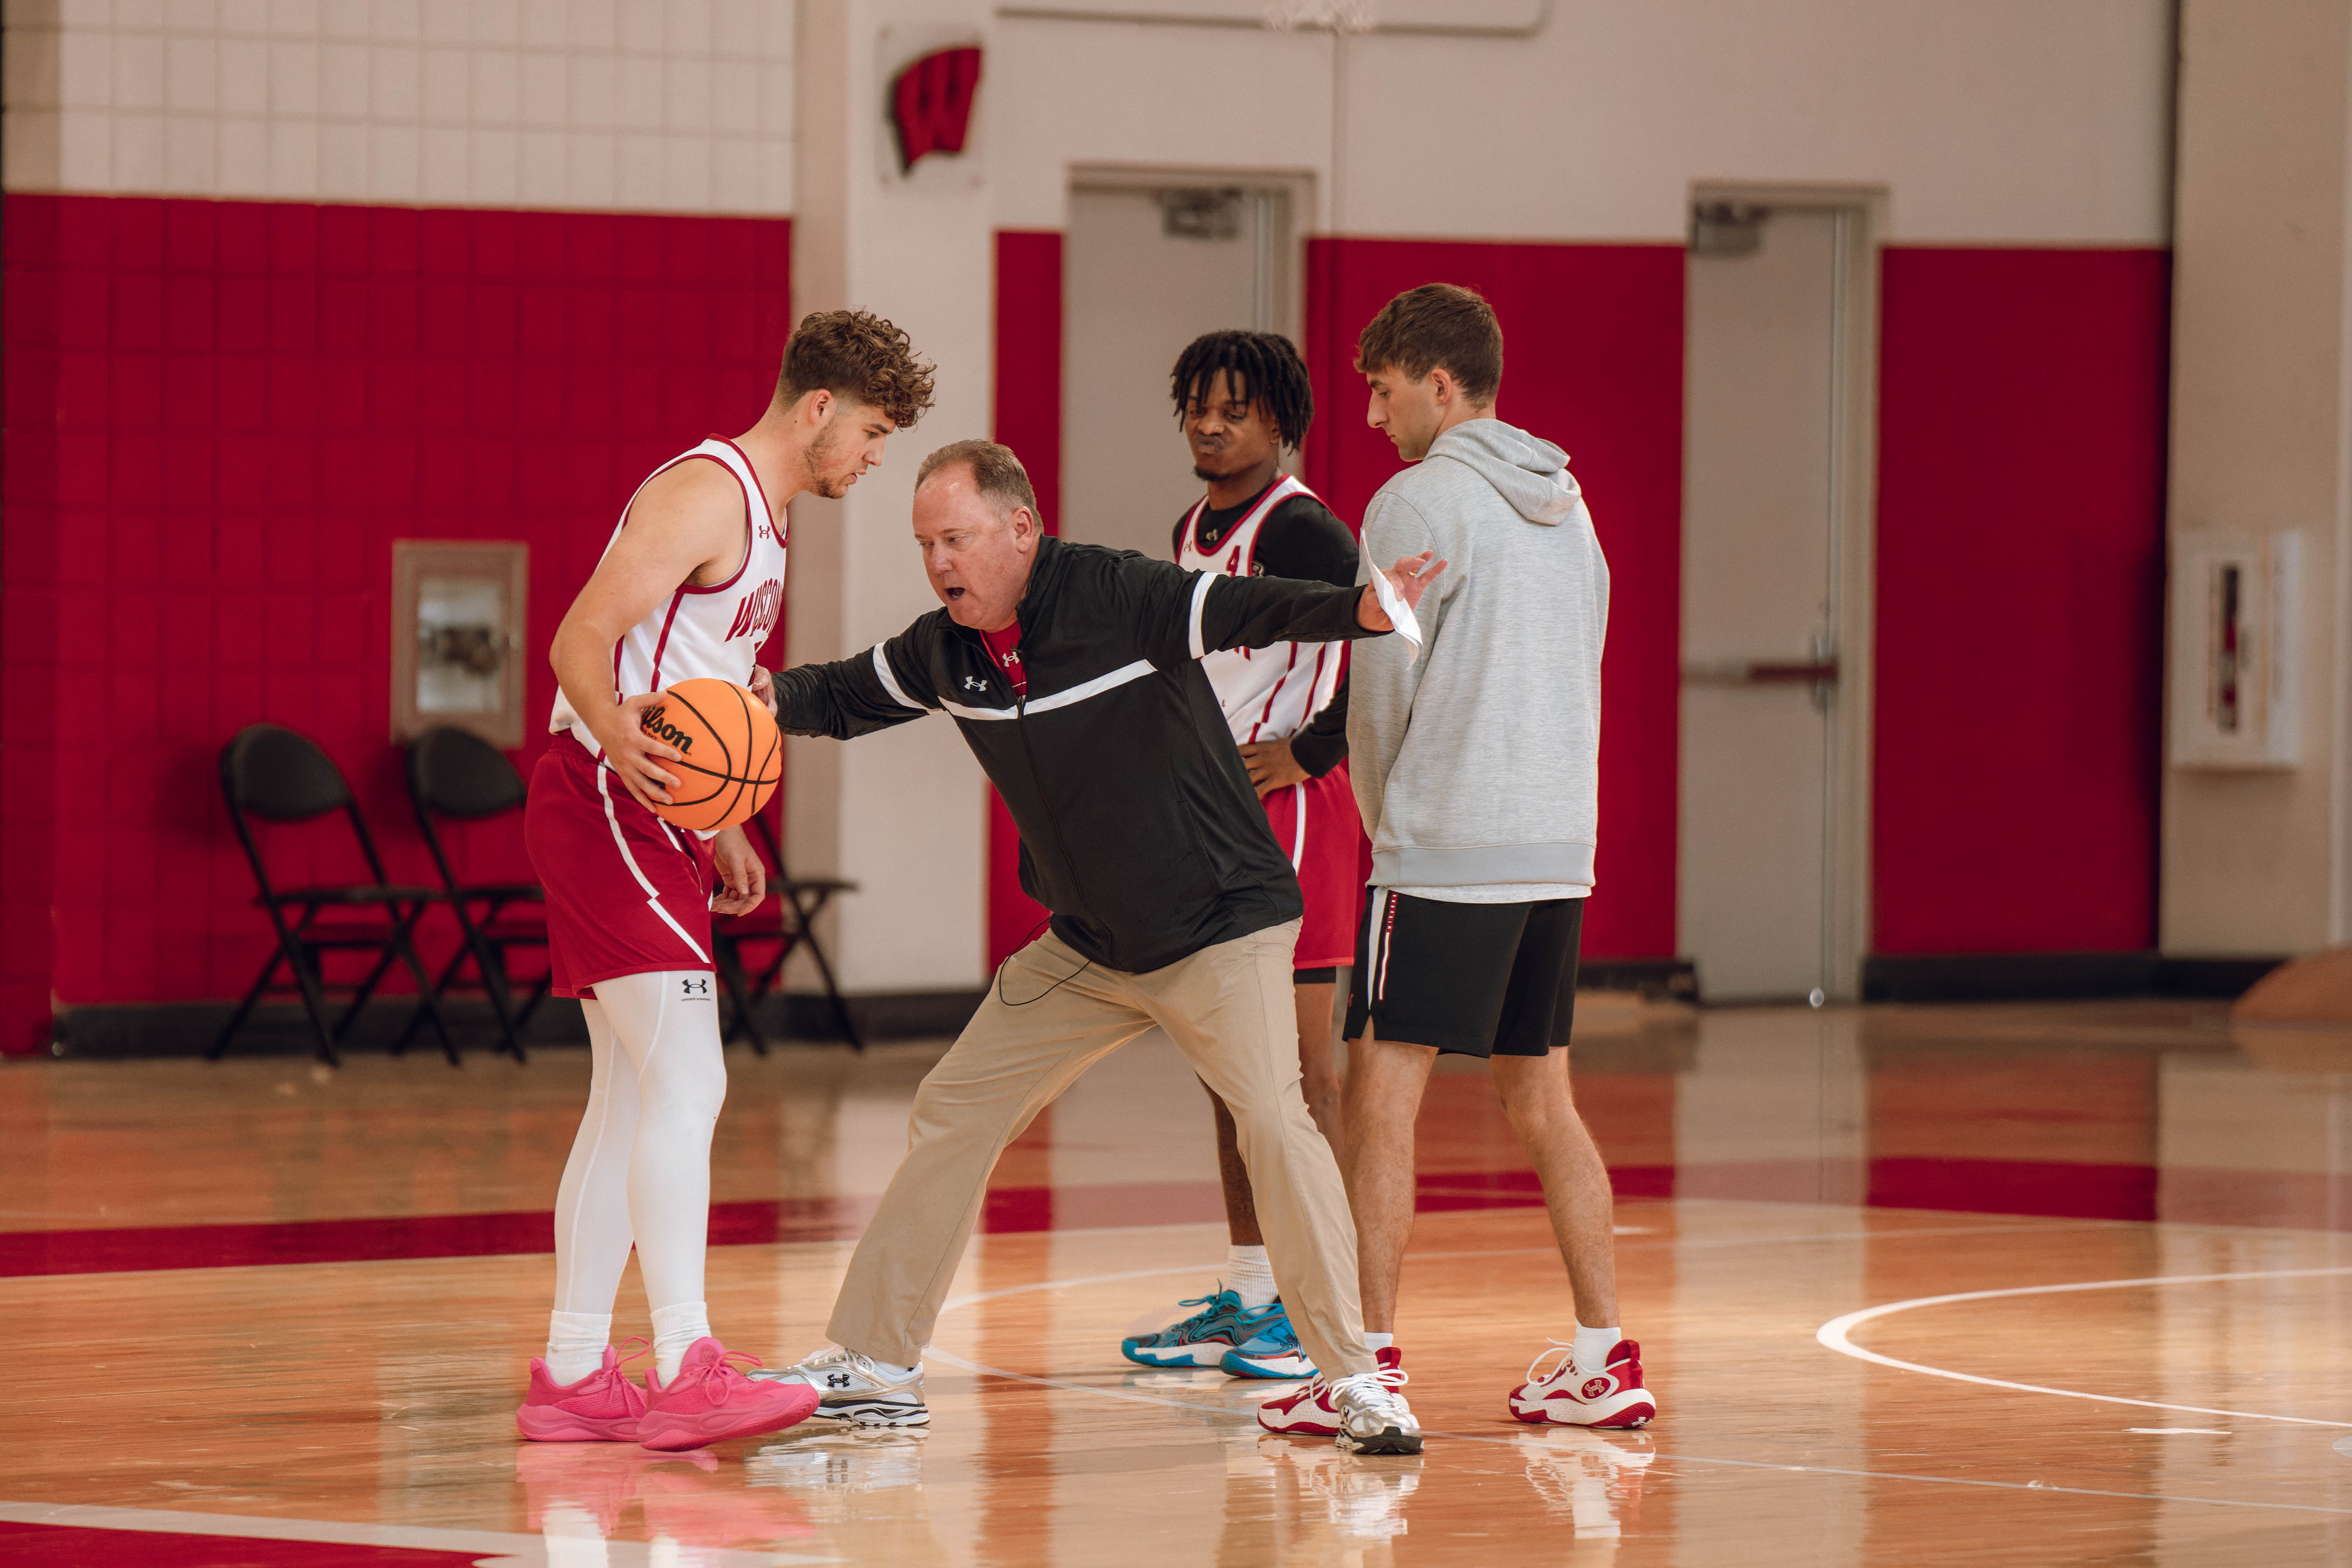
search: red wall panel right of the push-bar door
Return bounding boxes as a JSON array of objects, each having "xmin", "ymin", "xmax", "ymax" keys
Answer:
[{"xmin": 1872, "ymin": 249, "xmax": 2171, "ymax": 952}]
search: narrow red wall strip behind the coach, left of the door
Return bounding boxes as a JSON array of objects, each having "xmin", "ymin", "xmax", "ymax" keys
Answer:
[{"xmin": 988, "ymin": 228, "xmax": 1061, "ymax": 964}]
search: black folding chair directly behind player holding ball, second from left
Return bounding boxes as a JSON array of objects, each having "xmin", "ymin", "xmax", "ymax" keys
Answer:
[{"xmin": 409, "ymin": 724, "xmax": 553, "ymax": 1062}]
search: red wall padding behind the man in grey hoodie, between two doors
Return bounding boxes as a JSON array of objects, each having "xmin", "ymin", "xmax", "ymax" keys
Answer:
[{"xmin": 1303, "ymin": 237, "xmax": 1682, "ymax": 957}]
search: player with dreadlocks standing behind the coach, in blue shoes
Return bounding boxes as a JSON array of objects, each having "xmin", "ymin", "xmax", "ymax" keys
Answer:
[{"xmin": 1119, "ymin": 332, "xmax": 1364, "ymax": 1377}]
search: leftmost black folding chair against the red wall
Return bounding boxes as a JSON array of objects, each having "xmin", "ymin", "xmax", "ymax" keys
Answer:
[{"xmin": 204, "ymin": 724, "xmax": 459, "ymax": 1067}]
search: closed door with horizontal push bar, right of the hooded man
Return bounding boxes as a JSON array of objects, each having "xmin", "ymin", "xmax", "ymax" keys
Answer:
[{"xmin": 1677, "ymin": 204, "xmax": 1856, "ymax": 1004}]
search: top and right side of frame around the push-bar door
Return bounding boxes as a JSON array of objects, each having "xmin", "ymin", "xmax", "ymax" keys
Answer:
[{"xmin": 1689, "ymin": 181, "xmax": 1889, "ymax": 1001}]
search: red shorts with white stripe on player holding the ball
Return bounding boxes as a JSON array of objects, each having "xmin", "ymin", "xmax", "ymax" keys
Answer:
[{"xmin": 522, "ymin": 736, "xmax": 717, "ymax": 997}]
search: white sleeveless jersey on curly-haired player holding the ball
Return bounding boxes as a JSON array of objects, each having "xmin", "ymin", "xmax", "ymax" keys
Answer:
[{"xmin": 548, "ymin": 435, "xmax": 786, "ymax": 755}]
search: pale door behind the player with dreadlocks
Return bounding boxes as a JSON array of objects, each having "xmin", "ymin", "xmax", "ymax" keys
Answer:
[{"xmin": 1058, "ymin": 186, "xmax": 1296, "ymax": 557}]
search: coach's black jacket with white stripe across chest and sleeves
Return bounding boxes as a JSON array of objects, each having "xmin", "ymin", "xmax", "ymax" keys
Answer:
[{"xmin": 776, "ymin": 536, "xmax": 1374, "ymax": 973}]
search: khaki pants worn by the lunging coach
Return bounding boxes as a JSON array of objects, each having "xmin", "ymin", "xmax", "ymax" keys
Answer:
[{"xmin": 828, "ymin": 922, "xmax": 1374, "ymax": 1377}]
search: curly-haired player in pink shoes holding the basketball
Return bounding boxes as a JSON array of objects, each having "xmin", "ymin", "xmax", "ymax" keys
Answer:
[{"xmin": 515, "ymin": 310, "xmax": 932, "ymax": 1450}]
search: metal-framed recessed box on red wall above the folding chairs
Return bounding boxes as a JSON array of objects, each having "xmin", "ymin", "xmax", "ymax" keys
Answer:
[{"xmin": 393, "ymin": 538, "xmax": 532, "ymax": 750}]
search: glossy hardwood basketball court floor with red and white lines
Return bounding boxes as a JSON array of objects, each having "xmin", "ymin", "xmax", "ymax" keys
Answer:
[{"xmin": 0, "ymin": 997, "xmax": 2352, "ymax": 1568}]
